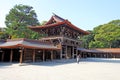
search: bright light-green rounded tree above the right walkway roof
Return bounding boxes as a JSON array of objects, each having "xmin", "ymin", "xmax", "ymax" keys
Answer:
[{"xmin": 94, "ymin": 20, "xmax": 120, "ymax": 48}]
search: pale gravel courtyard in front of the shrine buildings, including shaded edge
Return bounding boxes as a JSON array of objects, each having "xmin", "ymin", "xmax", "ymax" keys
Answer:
[{"xmin": 0, "ymin": 58, "xmax": 120, "ymax": 80}]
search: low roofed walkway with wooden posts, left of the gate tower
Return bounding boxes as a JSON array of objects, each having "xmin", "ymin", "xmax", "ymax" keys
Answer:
[{"xmin": 0, "ymin": 39, "xmax": 60, "ymax": 63}]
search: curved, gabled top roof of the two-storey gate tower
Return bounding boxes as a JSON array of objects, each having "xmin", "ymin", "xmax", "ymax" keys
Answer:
[{"xmin": 29, "ymin": 14, "xmax": 89, "ymax": 35}]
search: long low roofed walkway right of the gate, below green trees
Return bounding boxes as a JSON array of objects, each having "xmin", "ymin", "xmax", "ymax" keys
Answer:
[{"xmin": 77, "ymin": 48, "xmax": 120, "ymax": 58}]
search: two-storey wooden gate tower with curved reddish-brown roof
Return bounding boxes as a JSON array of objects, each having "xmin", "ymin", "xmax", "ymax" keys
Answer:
[{"xmin": 29, "ymin": 14, "xmax": 89, "ymax": 59}]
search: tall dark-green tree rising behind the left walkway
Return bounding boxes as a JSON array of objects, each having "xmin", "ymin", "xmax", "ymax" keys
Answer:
[{"xmin": 5, "ymin": 4, "xmax": 39, "ymax": 39}]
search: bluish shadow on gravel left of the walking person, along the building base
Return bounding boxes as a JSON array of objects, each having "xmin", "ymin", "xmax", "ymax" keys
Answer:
[{"xmin": 0, "ymin": 59, "xmax": 76, "ymax": 68}]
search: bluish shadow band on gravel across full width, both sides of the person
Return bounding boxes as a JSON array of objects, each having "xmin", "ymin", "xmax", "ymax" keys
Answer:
[{"xmin": 0, "ymin": 58, "xmax": 120, "ymax": 68}]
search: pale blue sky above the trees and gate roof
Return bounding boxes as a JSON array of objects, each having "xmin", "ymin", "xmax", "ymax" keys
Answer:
[{"xmin": 0, "ymin": 0, "xmax": 120, "ymax": 30}]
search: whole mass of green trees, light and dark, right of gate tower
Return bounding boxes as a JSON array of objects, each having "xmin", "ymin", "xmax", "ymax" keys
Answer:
[{"xmin": 84, "ymin": 20, "xmax": 120, "ymax": 48}]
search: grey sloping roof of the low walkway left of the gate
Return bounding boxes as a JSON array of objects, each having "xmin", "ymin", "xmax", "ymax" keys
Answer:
[{"xmin": 0, "ymin": 39, "xmax": 59, "ymax": 50}]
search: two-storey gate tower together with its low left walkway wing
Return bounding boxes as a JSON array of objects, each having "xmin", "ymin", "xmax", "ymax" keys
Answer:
[{"xmin": 0, "ymin": 14, "xmax": 89, "ymax": 63}]
